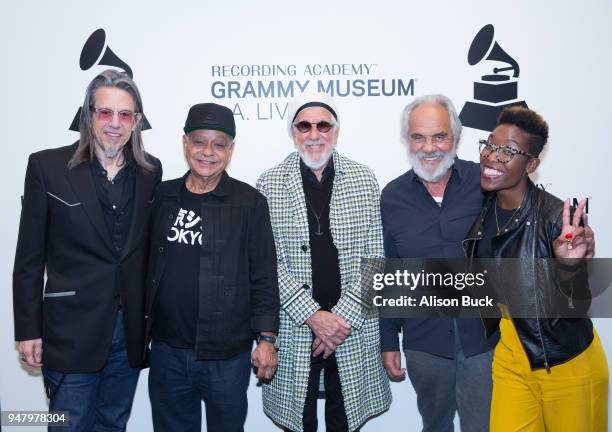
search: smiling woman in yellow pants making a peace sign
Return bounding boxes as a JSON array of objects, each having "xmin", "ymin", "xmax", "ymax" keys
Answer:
[{"xmin": 464, "ymin": 107, "xmax": 608, "ymax": 432}]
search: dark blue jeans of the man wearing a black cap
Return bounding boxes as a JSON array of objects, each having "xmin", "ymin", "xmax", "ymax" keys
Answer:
[{"xmin": 149, "ymin": 341, "xmax": 251, "ymax": 432}]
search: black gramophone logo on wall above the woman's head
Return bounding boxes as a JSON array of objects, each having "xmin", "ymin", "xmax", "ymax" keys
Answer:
[{"xmin": 459, "ymin": 24, "xmax": 527, "ymax": 131}]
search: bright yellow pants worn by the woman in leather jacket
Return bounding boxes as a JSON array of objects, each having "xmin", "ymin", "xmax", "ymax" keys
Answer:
[{"xmin": 490, "ymin": 318, "xmax": 608, "ymax": 432}]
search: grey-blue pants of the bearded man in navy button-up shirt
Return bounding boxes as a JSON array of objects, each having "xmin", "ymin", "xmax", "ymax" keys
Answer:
[{"xmin": 404, "ymin": 322, "xmax": 493, "ymax": 432}]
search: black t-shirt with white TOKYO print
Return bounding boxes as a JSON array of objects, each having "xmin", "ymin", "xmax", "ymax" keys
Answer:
[{"xmin": 152, "ymin": 185, "xmax": 210, "ymax": 348}]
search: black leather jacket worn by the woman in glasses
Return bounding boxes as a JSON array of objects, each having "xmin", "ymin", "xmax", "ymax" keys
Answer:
[{"xmin": 463, "ymin": 181, "xmax": 593, "ymax": 372}]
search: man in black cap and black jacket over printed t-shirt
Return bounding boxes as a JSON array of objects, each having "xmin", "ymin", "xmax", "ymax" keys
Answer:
[{"xmin": 146, "ymin": 103, "xmax": 279, "ymax": 432}]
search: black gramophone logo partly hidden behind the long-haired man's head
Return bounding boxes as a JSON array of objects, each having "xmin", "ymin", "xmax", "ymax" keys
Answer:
[{"xmin": 68, "ymin": 29, "xmax": 151, "ymax": 132}]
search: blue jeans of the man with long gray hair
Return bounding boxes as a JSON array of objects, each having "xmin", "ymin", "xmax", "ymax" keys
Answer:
[{"xmin": 42, "ymin": 311, "xmax": 140, "ymax": 432}]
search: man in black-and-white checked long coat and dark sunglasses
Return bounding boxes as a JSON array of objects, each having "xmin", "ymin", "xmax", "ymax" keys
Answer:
[{"xmin": 257, "ymin": 93, "xmax": 391, "ymax": 432}]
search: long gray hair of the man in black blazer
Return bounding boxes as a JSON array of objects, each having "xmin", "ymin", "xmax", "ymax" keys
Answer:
[{"xmin": 68, "ymin": 69, "xmax": 155, "ymax": 172}]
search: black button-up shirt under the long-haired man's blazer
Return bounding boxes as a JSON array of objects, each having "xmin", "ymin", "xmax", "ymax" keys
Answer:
[{"xmin": 90, "ymin": 157, "xmax": 135, "ymax": 256}]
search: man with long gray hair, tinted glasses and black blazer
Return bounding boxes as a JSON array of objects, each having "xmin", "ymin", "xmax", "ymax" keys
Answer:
[{"xmin": 13, "ymin": 70, "xmax": 162, "ymax": 431}]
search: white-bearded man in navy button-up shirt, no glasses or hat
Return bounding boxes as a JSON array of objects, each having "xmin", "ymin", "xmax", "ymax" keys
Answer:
[{"xmin": 380, "ymin": 95, "xmax": 499, "ymax": 432}]
